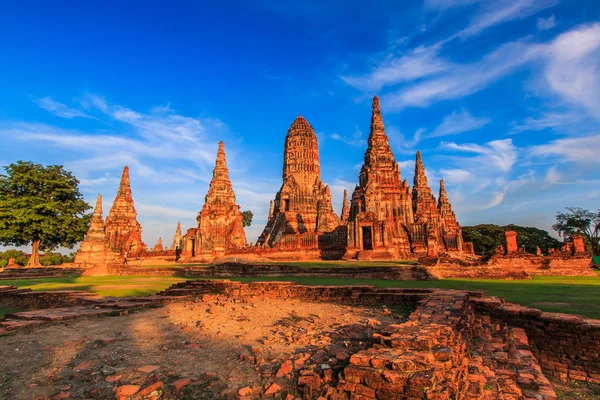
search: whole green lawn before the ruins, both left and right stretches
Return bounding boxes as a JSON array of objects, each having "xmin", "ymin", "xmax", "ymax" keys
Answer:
[{"xmin": 0, "ymin": 274, "xmax": 600, "ymax": 319}]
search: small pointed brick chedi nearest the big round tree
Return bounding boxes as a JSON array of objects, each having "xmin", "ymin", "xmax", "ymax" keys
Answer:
[{"xmin": 74, "ymin": 195, "xmax": 120, "ymax": 268}]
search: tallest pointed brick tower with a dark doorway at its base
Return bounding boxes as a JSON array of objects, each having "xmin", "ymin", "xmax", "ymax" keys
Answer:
[{"xmin": 345, "ymin": 96, "xmax": 413, "ymax": 258}]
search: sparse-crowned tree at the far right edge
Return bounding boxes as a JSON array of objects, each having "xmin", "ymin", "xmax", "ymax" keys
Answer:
[{"xmin": 552, "ymin": 207, "xmax": 600, "ymax": 256}]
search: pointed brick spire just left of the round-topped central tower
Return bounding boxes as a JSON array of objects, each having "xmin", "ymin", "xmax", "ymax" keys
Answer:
[{"xmin": 182, "ymin": 142, "xmax": 246, "ymax": 261}]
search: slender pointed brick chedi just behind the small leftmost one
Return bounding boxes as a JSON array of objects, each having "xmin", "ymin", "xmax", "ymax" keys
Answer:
[{"xmin": 105, "ymin": 166, "xmax": 146, "ymax": 256}]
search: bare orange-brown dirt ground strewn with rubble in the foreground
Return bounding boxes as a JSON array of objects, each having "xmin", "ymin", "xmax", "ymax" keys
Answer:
[{"xmin": 0, "ymin": 298, "xmax": 409, "ymax": 400}]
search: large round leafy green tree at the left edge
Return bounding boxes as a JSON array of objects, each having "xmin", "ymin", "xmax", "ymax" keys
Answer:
[{"xmin": 0, "ymin": 161, "xmax": 91, "ymax": 267}]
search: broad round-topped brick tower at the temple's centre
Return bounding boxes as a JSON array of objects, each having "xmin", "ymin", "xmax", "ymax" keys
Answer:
[{"xmin": 257, "ymin": 117, "xmax": 341, "ymax": 246}]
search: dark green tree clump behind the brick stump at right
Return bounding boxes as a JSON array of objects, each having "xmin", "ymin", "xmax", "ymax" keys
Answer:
[{"xmin": 463, "ymin": 224, "xmax": 561, "ymax": 256}]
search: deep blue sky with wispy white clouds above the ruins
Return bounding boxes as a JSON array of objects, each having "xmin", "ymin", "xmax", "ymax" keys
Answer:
[{"xmin": 0, "ymin": 0, "xmax": 600, "ymax": 245}]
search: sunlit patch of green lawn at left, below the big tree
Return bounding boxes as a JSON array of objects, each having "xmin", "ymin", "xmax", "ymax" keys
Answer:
[{"xmin": 0, "ymin": 276, "xmax": 191, "ymax": 297}]
